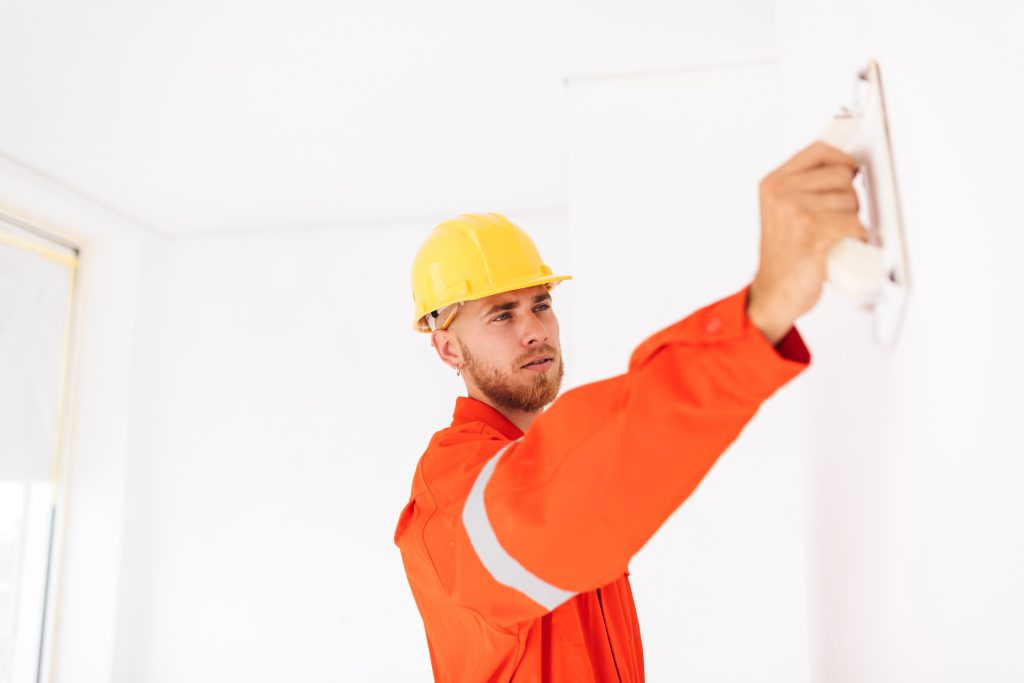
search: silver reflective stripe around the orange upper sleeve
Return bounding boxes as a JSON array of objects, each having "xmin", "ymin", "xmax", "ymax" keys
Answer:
[{"xmin": 462, "ymin": 441, "xmax": 574, "ymax": 609}]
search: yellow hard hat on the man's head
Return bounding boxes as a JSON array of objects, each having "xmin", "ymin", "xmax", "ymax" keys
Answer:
[{"xmin": 413, "ymin": 213, "xmax": 571, "ymax": 332}]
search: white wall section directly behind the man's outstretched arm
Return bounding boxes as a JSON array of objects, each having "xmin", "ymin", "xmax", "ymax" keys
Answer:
[{"xmin": 568, "ymin": 61, "xmax": 808, "ymax": 681}]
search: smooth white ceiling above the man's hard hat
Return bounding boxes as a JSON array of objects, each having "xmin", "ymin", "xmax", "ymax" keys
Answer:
[{"xmin": 0, "ymin": 0, "xmax": 775, "ymax": 233}]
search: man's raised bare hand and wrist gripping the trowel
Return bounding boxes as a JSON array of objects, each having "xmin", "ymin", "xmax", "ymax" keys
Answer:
[{"xmin": 746, "ymin": 142, "xmax": 867, "ymax": 345}]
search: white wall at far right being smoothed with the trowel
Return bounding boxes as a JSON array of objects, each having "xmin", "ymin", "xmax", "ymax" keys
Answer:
[{"xmin": 776, "ymin": 0, "xmax": 1024, "ymax": 683}]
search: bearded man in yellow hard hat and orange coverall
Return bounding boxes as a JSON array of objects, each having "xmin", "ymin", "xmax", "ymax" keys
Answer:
[{"xmin": 394, "ymin": 142, "xmax": 866, "ymax": 682}]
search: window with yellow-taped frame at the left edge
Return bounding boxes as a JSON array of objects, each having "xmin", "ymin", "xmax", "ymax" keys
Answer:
[{"xmin": 0, "ymin": 216, "xmax": 78, "ymax": 683}]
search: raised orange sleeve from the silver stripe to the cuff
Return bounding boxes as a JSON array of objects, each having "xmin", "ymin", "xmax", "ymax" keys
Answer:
[{"xmin": 482, "ymin": 287, "xmax": 810, "ymax": 592}]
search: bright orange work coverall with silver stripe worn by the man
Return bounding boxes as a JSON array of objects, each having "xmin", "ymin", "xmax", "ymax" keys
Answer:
[{"xmin": 394, "ymin": 287, "xmax": 810, "ymax": 683}]
